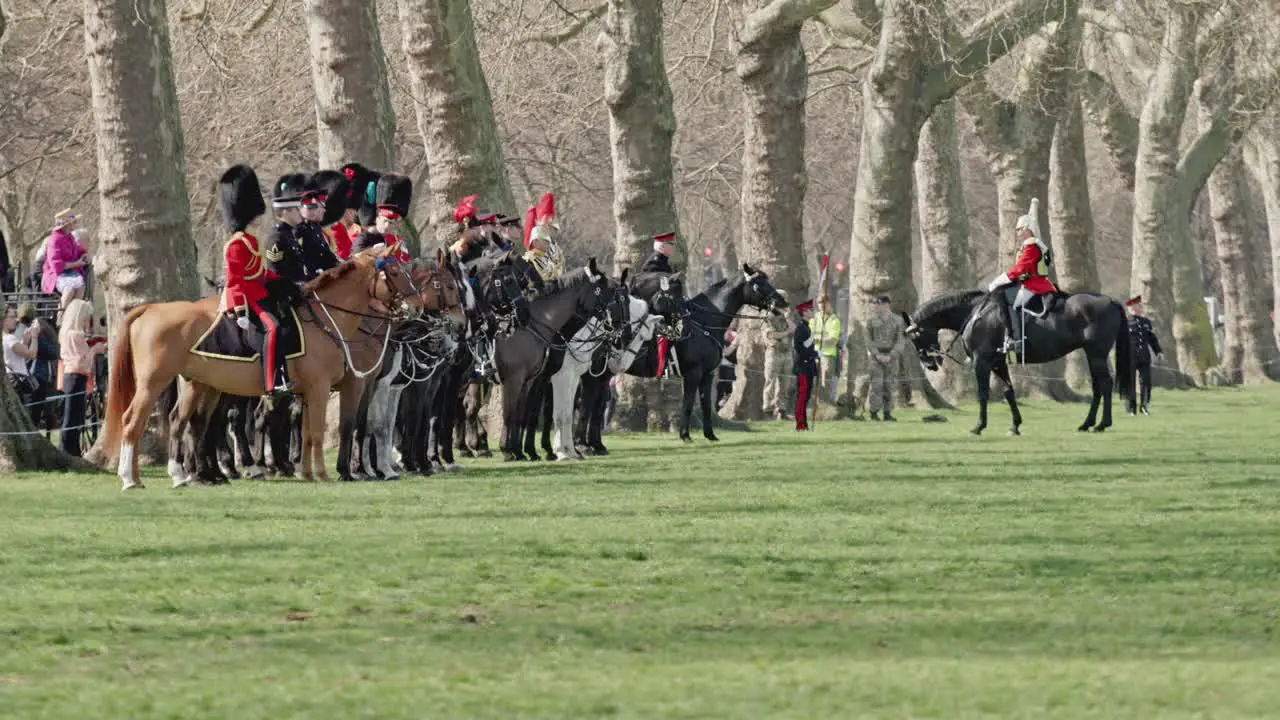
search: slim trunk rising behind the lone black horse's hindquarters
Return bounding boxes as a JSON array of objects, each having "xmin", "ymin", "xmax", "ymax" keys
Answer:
[{"xmin": 1048, "ymin": 94, "xmax": 1102, "ymax": 388}]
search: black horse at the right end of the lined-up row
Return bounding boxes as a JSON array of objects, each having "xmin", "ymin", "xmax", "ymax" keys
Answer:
[{"xmin": 627, "ymin": 263, "xmax": 787, "ymax": 442}]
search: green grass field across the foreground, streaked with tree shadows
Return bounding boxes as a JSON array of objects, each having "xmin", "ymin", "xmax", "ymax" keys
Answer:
[{"xmin": 0, "ymin": 388, "xmax": 1280, "ymax": 720}]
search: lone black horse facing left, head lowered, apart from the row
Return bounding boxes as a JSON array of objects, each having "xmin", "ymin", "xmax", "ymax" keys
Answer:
[{"xmin": 906, "ymin": 290, "xmax": 1133, "ymax": 434}]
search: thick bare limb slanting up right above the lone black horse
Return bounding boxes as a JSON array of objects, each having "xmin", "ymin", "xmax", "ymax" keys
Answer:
[{"xmin": 924, "ymin": 0, "xmax": 1066, "ymax": 108}]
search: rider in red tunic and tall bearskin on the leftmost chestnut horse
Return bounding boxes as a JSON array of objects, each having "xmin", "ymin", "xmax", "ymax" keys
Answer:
[{"xmin": 218, "ymin": 165, "xmax": 292, "ymax": 392}]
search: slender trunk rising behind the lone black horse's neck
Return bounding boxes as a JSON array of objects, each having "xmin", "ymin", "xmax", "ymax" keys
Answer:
[{"xmin": 916, "ymin": 100, "xmax": 974, "ymax": 400}]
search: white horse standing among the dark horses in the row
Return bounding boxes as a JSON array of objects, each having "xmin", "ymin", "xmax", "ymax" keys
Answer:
[{"xmin": 552, "ymin": 297, "xmax": 662, "ymax": 460}]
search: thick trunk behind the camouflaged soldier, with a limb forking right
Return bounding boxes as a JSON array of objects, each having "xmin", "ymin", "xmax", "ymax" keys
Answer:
[{"xmin": 849, "ymin": 0, "xmax": 1064, "ymax": 348}]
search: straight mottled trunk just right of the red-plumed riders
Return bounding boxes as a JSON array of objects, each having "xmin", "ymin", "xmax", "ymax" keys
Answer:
[{"xmin": 596, "ymin": 0, "xmax": 694, "ymax": 432}]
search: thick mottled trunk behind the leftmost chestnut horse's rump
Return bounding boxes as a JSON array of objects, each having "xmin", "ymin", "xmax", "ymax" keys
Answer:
[{"xmin": 84, "ymin": 0, "xmax": 198, "ymax": 327}]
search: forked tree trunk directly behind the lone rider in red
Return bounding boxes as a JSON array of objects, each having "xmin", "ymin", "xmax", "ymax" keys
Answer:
[{"xmin": 965, "ymin": 0, "xmax": 1088, "ymax": 400}]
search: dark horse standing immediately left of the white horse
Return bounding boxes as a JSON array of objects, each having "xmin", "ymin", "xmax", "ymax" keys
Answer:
[{"xmin": 493, "ymin": 258, "xmax": 609, "ymax": 461}]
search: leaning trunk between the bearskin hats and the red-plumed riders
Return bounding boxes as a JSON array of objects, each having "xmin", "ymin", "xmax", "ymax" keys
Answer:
[{"xmin": 398, "ymin": 0, "xmax": 509, "ymax": 246}]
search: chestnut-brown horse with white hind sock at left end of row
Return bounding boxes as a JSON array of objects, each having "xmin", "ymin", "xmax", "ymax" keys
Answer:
[{"xmin": 104, "ymin": 249, "xmax": 421, "ymax": 489}]
